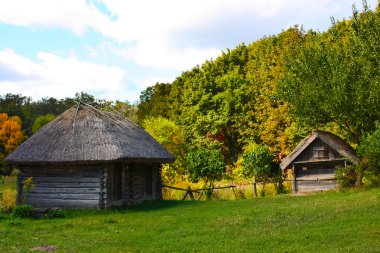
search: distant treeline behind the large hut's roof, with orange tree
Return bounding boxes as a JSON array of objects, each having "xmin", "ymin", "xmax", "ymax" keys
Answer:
[{"xmin": 0, "ymin": 92, "xmax": 137, "ymax": 174}]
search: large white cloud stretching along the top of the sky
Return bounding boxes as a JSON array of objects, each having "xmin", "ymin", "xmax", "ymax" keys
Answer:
[{"xmin": 0, "ymin": 0, "xmax": 374, "ymax": 69}]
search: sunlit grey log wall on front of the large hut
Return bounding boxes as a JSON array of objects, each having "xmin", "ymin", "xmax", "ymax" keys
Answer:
[{"xmin": 18, "ymin": 166, "xmax": 103, "ymax": 209}]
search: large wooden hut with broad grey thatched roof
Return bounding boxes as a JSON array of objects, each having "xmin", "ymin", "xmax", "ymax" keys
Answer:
[{"xmin": 5, "ymin": 103, "xmax": 175, "ymax": 209}]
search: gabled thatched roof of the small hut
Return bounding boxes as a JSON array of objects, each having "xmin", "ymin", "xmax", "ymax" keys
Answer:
[{"xmin": 280, "ymin": 130, "xmax": 358, "ymax": 170}]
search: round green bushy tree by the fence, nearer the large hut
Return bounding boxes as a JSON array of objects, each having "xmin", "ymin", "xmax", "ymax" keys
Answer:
[{"xmin": 184, "ymin": 149, "xmax": 226, "ymax": 190}]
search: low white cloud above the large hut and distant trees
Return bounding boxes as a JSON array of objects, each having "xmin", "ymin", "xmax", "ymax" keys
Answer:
[{"xmin": 0, "ymin": 49, "xmax": 127, "ymax": 101}]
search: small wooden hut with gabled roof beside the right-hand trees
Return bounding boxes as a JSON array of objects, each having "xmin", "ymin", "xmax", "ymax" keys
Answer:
[{"xmin": 280, "ymin": 130, "xmax": 358, "ymax": 192}]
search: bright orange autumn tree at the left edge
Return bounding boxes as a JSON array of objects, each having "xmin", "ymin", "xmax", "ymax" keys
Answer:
[{"xmin": 0, "ymin": 113, "xmax": 26, "ymax": 174}]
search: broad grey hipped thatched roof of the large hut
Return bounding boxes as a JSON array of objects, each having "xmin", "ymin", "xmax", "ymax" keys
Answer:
[{"xmin": 5, "ymin": 103, "xmax": 175, "ymax": 164}]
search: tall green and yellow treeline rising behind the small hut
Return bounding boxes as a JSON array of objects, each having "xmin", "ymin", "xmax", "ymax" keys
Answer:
[{"xmin": 137, "ymin": 2, "xmax": 380, "ymax": 186}]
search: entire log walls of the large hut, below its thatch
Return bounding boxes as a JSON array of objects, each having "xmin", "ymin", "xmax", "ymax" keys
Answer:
[{"xmin": 18, "ymin": 163, "xmax": 162, "ymax": 209}]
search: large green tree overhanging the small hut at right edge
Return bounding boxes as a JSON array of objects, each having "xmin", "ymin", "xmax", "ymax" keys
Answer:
[{"xmin": 279, "ymin": 2, "xmax": 380, "ymax": 144}]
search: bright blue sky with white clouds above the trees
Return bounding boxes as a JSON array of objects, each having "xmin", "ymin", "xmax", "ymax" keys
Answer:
[{"xmin": 0, "ymin": 0, "xmax": 377, "ymax": 103}]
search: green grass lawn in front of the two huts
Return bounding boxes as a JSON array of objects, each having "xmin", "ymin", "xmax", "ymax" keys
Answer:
[{"xmin": 0, "ymin": 189, "xmax": 380, "ymax": 252}]
